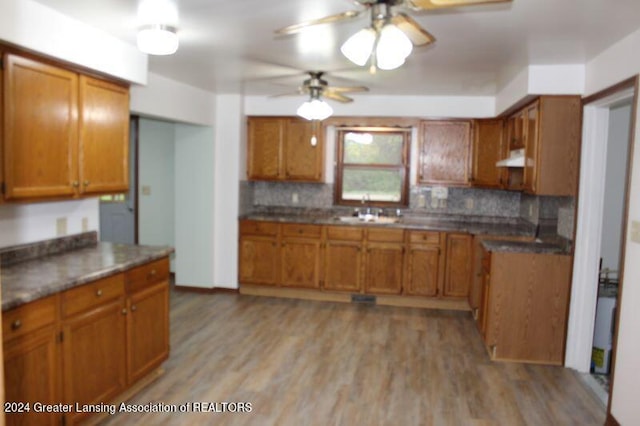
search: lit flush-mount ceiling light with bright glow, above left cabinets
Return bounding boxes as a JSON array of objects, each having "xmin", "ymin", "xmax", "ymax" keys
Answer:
[{"xmin": 137, "ymin": 0, "xmax": 179, "ymax": 55}]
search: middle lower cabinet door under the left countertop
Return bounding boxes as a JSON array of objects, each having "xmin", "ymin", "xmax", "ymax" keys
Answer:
[{"xmin": 62, "ymin": 299, "xmax": 126, "ymax": 422}]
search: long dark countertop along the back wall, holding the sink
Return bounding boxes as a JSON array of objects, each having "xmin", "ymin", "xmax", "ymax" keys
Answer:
[{"xmin": 239, "ymin": 213, "xmax": 536, "ymax": 237}]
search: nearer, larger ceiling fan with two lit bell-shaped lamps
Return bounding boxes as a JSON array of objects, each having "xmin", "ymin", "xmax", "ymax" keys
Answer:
[{"xmin": 275, "ymin": 0, "xmax": 512, "ymax": 72}]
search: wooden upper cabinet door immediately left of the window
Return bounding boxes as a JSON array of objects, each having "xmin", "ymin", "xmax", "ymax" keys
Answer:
[{"xmin": 283, "ymin": 119, "xmax": 324, "ymax": 182}]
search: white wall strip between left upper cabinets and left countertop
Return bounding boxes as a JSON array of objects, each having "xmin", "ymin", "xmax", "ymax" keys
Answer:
[{"xmin": 0, "ymin": 198, "xmax": 100, "ymax": 247}]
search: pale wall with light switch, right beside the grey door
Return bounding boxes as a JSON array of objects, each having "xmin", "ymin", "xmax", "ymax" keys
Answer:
[{"xmin": 137, "ymin": 118, "xmax": 175, "ymax": 253}]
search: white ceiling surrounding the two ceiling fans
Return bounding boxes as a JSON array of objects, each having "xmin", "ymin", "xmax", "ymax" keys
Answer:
[{"xmin": 32, "ymin": 0, "xmax": 640, "ymax": 96}]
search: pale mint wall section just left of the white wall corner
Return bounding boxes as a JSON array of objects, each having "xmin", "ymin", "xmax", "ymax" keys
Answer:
[{"xmin": 174, "ymin": 124, "xmax": 216, "ymax": 288}]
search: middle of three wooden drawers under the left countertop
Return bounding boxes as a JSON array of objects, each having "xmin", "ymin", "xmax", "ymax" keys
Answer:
[{"xmin": 62, "ymin": 274, "xmax": 124, "ymax": 317}]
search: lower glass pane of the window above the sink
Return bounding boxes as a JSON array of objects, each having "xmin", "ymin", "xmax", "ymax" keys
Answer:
[{"xmin": 342, "ymin": 166, "xmax": 402, "ymax": 202}]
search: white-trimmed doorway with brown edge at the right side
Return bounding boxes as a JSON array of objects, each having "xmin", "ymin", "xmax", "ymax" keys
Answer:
[{"xmin": 565, "ymin": 78, "xmax": 637, "ymax": 405}]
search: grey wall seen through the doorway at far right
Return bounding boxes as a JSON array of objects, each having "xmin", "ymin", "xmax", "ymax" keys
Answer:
[{"xmin": 601, "ymin": 103, "xmax": 631, "ymax": 271}]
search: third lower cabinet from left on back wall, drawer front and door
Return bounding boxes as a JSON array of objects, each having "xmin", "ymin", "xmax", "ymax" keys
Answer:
[{"xmin": 322, "ymin": 226, "xmax": 364, "ymax": 293}]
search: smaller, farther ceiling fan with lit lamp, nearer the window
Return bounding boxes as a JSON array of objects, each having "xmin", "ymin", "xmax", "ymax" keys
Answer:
[{"xmin": 276, "ymin": 71, "xmax": 369, "ymax": 120}]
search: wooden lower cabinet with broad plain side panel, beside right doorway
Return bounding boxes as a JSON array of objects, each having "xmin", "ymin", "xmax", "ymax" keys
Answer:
[{"xmin": 479, "ymin": 252, "xmax": 572, "ymax": 365}]
